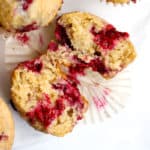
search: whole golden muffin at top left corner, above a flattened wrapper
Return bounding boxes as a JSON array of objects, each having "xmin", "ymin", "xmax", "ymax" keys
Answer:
[{"xmin": 0, "ymin": 0, "xmax": 62, "ymax": 32}]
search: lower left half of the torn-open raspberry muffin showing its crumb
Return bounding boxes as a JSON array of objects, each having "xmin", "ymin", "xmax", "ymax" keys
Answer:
[{"xmin": 11, "ymin": 41, "xmax": 88, "ymax": 136}]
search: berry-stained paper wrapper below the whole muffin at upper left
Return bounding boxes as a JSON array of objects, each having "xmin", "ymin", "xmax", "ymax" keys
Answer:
[{"xmin": 0, "ymin": 27, "xmax": 53, "ymax": 70}]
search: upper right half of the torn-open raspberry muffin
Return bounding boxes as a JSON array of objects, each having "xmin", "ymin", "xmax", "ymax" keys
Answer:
[{"xmin": 55, "ymin": 12, "xmax": 136, "ymax": 79}]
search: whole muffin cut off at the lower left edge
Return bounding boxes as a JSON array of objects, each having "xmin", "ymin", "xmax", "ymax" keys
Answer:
[{"xmin": 0, "ymin": 99, "xmax": 14, "ymax": 150}]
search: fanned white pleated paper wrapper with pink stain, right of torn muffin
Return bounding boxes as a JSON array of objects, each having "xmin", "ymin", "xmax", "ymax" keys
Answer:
[{"xmin": 78, "ymin": 69, "xmax": 131, "ymax": 124}]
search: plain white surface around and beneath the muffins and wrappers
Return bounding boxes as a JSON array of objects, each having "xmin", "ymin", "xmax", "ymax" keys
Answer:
[{"xmin": 0, "ymin": 0, "xmax": 150, "ymax": 150}]
